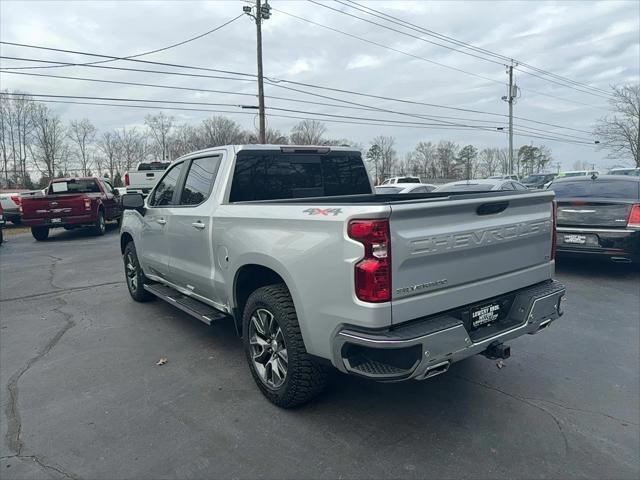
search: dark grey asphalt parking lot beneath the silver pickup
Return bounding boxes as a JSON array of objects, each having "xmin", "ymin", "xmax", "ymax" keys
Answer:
[{"xmin": 0, "ymin": 227, "xmax": 640, "ymax": 479}]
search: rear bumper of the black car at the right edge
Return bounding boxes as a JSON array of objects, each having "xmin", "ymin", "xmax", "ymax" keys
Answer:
[{"xmin": 556, "ymin": 227, "xmax": 640, "ymax": 262}]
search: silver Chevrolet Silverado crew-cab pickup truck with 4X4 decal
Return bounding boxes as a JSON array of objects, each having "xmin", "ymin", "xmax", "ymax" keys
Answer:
[{"xmin": 120, "ymin": 145, "xmax": 565, "ymax": 407}]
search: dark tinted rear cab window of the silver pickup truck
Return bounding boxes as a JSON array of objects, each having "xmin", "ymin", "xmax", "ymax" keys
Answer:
[{"xmin": 229, "ymin": 150, "xmax": 371, "ymax": 202}]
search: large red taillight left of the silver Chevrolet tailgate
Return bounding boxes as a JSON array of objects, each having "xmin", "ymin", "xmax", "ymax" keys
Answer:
[{"xmin": 348, "ymin": 220, "xmax": 391, "ymax": 302}]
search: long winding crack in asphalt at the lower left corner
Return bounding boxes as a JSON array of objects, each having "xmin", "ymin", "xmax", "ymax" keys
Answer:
[{"xmin": 5, "ymin": 298, "xmax": 76, "ymax": 478}]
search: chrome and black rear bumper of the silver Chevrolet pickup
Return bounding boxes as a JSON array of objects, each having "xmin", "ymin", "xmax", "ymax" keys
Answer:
[{"xmin": 333, "ymin": 281, "xmax": 565, "ymax": 381}]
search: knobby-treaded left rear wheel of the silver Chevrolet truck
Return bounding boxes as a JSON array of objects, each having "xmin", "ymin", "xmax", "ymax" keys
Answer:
[{"xmin": 242, "ymin": 284, "xmax": 329, "ymax": 408}]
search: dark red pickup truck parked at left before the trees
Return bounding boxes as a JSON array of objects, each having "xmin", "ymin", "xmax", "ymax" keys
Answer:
[{"xmin": 22, "ymin": 177, "xmax": 122, "ymax": 240}]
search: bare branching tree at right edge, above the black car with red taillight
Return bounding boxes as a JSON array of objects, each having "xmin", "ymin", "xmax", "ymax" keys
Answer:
[{"xmin": 594, "ymin": 84, "xmax": 640, "ymax": 167}]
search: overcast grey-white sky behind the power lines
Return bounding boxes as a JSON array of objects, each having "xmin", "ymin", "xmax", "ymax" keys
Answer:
[{"xmin": 0, "ymin": 0, "xmax": 640, "ymax": 169}]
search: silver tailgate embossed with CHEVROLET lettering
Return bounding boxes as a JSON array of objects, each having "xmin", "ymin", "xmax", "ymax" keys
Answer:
[{"xmin": 390, "ymin": 191, "xmax": 553, "ymax": 324}]
